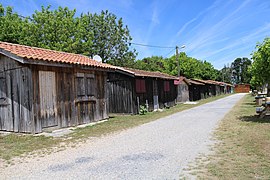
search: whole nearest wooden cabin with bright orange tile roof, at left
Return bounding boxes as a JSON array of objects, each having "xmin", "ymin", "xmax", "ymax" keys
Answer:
[{"xmin": 0, "ymin": 42, "xmax": 115, "ymax": 133}]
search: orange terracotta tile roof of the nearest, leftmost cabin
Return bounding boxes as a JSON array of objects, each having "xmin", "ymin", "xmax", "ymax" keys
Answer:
[{"xmin": 0, "ymin": 41, "xmax": 116, "ymax": 69}]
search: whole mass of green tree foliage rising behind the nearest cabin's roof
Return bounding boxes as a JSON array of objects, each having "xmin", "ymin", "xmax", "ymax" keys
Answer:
[{"xmin": 0, "ymin": 4, "xmax": 136, "ymax": 67}]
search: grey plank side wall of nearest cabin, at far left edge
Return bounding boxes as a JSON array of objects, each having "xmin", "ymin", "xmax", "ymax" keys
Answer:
[{"xmin": 0, "ymin": 55, "xmax": 32, "ymax": 132}]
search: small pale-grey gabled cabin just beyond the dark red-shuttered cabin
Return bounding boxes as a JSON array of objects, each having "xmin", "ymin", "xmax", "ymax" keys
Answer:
[{"xmin": 174, "ymin": 76, "xmax": 191, "ymax": 102}]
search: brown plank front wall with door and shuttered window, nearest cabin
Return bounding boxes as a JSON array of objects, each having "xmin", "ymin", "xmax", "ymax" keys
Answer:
[{"xmin": 32, "ymin": 66, "xmax": 108, "ymax": 132}]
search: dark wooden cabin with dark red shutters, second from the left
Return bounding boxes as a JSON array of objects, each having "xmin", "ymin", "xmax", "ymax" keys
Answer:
[{"xmin": 108, "ymin": 68, "xmax": 177, "ymax": 114}]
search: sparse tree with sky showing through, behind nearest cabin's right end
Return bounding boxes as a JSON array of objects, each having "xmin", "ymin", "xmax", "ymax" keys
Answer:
[{"xmin": 81, "ymin": 10, "xmax": 136, "ymax": 67}]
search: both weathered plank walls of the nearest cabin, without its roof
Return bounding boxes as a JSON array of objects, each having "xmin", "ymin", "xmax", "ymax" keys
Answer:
[{"xmin": 0, "ymin": 55, "xmax": 108, "ymax": 133}]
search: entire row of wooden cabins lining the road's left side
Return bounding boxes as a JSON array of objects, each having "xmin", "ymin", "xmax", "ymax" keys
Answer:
[{"xmin": 0, "ymin": 42, "xmax": 231, "ymax": 133}]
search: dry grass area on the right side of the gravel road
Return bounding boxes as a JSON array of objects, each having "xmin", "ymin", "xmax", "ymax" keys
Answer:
[{"xmin": 185, "ymin": 95, "xmax": 270, "ymax": 179}]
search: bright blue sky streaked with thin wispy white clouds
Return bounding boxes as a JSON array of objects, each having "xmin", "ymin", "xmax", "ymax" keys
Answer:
[{"xmin": 0, "ymin": 0, "xmax": 270, "ymax": 69}]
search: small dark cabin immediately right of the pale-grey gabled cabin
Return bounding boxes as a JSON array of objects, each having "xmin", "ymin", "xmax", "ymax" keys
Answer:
[{"xmin": 188, "ymin": 79, "xmax": 205, "ymax": 101}]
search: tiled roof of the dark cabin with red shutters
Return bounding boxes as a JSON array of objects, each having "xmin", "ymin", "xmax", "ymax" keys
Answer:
[{"xmin": 118, "ymin": 67, "xmax": 178, "ymax": 80}]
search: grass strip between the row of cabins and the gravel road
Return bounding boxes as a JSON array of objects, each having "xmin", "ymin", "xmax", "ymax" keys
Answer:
[{"xmin": 0, "ymin": 95, "xmax": 232, "ymax": 161}]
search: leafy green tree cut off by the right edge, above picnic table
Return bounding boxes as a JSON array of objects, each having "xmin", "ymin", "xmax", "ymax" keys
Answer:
[{"xmin": 251, "ymin": 37, "xmax": 270, "ymax": 96}]
